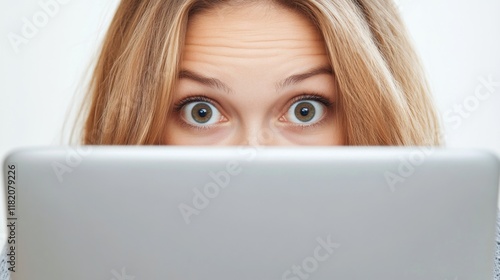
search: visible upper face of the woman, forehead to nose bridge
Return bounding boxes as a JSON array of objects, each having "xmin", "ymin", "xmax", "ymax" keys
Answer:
[{"xmin": 165, "ymin": 3, "xmax": 342, "ymax": 145}]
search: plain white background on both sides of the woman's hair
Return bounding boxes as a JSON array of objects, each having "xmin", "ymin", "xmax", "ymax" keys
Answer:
[{"xmin": 0, "ymin": 0, "xmax": 500, "ymax": 158}]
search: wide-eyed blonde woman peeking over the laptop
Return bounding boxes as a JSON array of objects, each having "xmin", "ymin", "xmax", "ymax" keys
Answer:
[{"xmin": 75, "ymin": 0, "xmax": 498, "ymax": 276}]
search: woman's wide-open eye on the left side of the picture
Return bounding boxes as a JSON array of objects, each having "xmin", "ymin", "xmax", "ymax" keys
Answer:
[{"xmin": 181, "ymin": 101, "xmax": 221, "ymax": 126}]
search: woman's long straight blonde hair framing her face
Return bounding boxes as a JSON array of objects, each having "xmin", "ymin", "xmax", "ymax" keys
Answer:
[{"xmin": 76, "ymin": 0, "xmax": 439, "ymax": 145}]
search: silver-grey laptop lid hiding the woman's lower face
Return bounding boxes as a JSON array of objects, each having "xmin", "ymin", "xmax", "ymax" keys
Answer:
[{"xmin": 0, "ymin": 146, "xmax": 499, "ymax": 280}]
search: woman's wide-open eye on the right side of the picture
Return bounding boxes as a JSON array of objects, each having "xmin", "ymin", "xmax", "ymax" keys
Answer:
[{"xmin": 285, "ymin": 100, "xmax": 325, "ymax": 124}]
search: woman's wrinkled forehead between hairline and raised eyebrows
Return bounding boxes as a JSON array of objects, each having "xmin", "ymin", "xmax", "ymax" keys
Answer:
[{"xmin": 183, "ymin": 1, "xmax": 326, "ymax": 68}]
